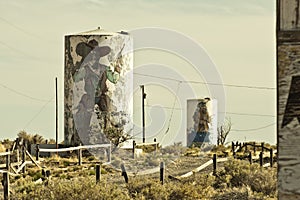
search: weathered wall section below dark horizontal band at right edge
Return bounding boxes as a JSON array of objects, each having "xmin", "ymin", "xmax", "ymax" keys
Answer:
[{"xmin": 278, "ymin": 43, "xmax": 300, "ymax": 197}]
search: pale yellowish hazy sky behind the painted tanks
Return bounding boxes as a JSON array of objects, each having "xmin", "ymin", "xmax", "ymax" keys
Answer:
[{"xmin": 0, "ymin": 0, "xmax": 276, "ymax": 143}]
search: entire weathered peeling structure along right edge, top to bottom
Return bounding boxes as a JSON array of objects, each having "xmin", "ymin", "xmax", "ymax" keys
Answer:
[{"xmin": 276, "ymin": 0, "xmax": 300, "ymax": 200}]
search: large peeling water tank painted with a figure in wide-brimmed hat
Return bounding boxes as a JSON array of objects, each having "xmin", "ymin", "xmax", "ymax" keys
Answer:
[{"xmin": 64, "ymin": 28, "xmax": 133, "ymax": 146}]
